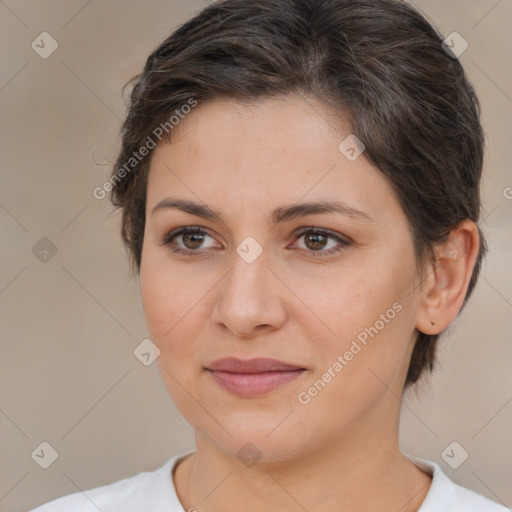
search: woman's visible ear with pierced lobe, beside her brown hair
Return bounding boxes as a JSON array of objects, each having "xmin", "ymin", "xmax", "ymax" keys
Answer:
[{"xmin": 416, "ymin": 220, "xmax": 480, "ymax": 334}]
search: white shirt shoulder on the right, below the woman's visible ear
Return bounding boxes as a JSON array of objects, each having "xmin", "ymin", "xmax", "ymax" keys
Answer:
[{"xmin": 407, "ymin": 455, "xmax": 510, "ymax": 512}]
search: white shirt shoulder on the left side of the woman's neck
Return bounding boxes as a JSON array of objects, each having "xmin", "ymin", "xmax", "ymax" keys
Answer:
[{"xmin": 30, "ymin": 456, "xmax": 188, "ymax": 512}]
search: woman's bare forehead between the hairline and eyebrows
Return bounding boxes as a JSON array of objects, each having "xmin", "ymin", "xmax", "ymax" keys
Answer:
[{"xmin": 147, "ymin": 97, "xmax": 400, "ymax": 224}]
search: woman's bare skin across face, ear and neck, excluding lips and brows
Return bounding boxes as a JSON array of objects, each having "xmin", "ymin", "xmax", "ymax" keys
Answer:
[{"xmin": 140, "ymin": 96, "xmax": 478, "ymax": 512}]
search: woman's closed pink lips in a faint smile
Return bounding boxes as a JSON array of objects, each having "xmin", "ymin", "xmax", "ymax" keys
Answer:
[{"xmin": 205, "ymin": 358, "xmax": 307, "ymax": 398}]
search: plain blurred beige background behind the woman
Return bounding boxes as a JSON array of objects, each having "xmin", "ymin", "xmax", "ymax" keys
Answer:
[{"xmin": 0, "ymin": 0, "xmax": 512, "ymax": 512}]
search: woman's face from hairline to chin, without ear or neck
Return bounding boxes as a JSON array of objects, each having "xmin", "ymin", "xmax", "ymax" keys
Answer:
[{"xmin": 140, "ymin": 96, "xmax": 419, "ymax": 461}]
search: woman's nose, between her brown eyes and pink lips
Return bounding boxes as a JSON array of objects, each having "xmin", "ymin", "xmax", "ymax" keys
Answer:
[{"xmin": 209, "ymin": 246, "xmax": 288, "ymax": 338}]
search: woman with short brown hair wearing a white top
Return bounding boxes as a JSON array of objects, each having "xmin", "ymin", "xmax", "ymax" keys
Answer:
[{"xmin": 31, "ymin": 0, "xmax": 507, "ymax": 512}]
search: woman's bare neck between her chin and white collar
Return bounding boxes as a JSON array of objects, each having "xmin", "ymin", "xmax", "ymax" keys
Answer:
[{"xmin": 176, "ymin": 400, "xmax": 431, "ymax": 512}]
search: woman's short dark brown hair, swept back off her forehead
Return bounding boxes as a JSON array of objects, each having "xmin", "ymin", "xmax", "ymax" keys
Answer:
[{"xmin": 111, "ymin": 0, "xmax": 487, "ymax": 387}]
